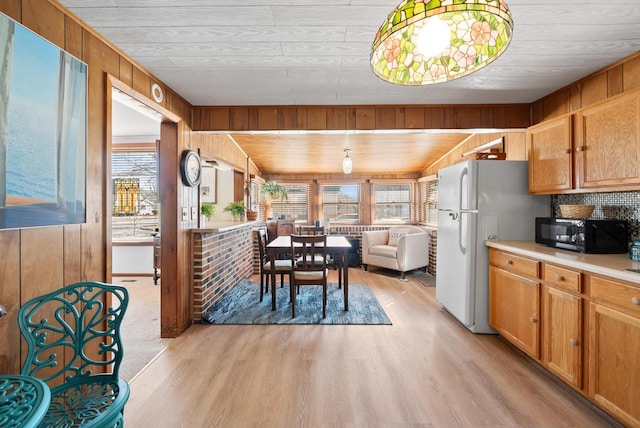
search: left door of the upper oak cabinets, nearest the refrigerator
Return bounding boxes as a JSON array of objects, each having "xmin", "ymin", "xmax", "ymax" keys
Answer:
[{"xmin": 527, "ymin": 115, "xmax": 573, "ymax": 194}]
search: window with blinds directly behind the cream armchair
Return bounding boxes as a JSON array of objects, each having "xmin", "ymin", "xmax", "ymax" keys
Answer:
[{"xmin": 372, "ymin": 183, "xmax": 412, "ymax": 223}]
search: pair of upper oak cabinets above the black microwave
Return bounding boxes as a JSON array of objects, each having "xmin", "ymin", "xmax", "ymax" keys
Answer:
[{"xmin": 527, "ymin": 91, "xmax": 640, "ymax": 194}]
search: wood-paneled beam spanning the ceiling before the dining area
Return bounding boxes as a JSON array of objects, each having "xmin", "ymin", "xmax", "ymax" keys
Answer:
[{"xmin": 193, "ymin": 104, "xmax": 530, "ymax": 131}]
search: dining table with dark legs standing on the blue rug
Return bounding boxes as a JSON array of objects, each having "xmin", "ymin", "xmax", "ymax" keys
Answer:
[{"xmin": 267, "ymin": 235, "xmax": 351, "ymax": 311}]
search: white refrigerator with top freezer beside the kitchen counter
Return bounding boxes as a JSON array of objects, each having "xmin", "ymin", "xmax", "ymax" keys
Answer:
[{"xmin": 436, "ymin": 160, "xmax": 551, "ymax": 333}]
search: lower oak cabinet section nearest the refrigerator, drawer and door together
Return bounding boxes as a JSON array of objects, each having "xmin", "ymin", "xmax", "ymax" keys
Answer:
[{"xmin": 489, "ymin": 249, "xmax": 540, "ymax": 360}]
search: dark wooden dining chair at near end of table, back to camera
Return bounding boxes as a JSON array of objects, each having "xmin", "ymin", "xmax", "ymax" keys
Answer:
[{"xmin": 289, "ymin": 235, "xmax": 328, "ymax": 318}]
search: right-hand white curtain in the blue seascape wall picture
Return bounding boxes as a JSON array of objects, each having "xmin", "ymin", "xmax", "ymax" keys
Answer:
[{"xmin": 56, "ymin": 51, "xmax": 87, "ymax": 214}]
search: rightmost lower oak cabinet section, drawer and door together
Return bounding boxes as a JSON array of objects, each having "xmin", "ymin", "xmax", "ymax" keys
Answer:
[{"xmin": 589, "ymin": 275, "xmax": 640, "ymax": 427}]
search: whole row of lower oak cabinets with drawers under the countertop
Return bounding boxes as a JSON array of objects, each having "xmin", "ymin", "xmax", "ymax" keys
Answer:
[{"xmin": 489, "ymin": 248, "xmax": 640, "ymax": 428}]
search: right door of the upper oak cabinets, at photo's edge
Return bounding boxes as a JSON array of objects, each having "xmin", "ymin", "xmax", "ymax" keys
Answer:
[{"xmin": 575, "ymin": 91, "xmax": 640, "ymax": 191}]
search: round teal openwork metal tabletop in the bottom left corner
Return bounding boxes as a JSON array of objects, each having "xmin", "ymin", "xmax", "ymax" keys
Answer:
[{"xmin": 0, "ymin": 374, "xmax": 51, "ymax": 428}]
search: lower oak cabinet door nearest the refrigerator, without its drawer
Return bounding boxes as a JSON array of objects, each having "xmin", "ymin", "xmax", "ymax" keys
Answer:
[{"xmin": 489, "ymin": 266, "xmax": 540, "ymax": 359}]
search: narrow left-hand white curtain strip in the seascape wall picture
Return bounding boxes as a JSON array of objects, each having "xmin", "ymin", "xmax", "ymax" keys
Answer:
[{"xmin": 0, "ymin": 17, "xmax": 14, "ymax": 207}]
